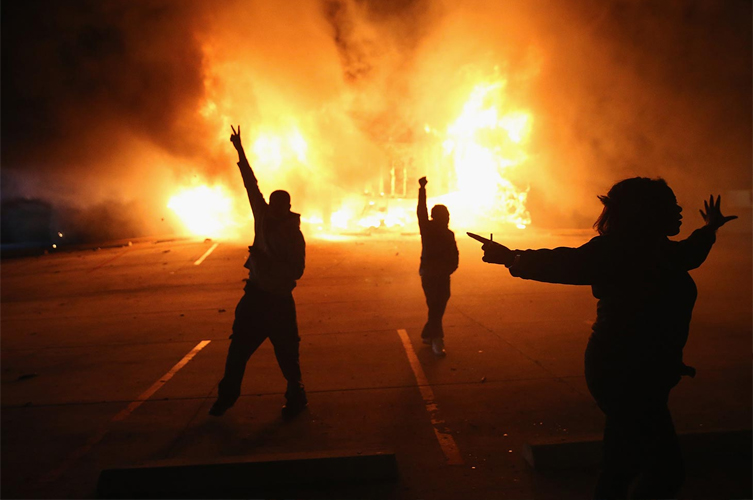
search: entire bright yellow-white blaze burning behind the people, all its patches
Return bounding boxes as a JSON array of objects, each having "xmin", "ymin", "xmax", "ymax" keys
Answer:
[{"xmin": 168, "ymin": 75, "xmax": 532, "ymax": 238}]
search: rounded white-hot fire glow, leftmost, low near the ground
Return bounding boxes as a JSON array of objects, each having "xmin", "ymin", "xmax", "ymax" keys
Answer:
[{"xmin": 167, "ymin": 186, "xmax": 238, "ymax": 238}]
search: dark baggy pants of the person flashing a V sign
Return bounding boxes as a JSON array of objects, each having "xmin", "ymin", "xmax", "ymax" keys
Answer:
[{"xmin": 218, "ymin": 283, "xmax": 306, "ymax": 407}]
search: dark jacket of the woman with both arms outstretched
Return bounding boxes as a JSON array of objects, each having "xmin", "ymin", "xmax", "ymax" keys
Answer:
[{"xmin": 510, "ymin": 227, "xmax": 716, "ymax": 385}]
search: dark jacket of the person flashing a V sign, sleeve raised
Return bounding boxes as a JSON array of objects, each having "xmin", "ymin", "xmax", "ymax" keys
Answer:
[{"xmin": 238, "ymin": 156, "xmax": 306, "ymax": 295}]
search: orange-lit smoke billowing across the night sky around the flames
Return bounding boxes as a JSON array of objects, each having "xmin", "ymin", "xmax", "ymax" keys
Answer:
[{"xmin": 2, "ymin": 0, "xmax": 753, "ymax": 242}]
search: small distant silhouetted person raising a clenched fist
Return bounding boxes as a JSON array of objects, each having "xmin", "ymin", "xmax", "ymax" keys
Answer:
[{"xmin": 416, "ymin": 177, "xmax": 458, "ymax": 356}]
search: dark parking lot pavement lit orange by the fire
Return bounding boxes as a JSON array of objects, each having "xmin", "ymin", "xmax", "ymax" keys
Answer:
[{"xmin": 0, "ymin": 231, "xmax": 752, "ymax": 499}]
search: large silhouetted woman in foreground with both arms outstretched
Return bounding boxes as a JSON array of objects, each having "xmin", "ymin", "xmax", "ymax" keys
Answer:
[{"xmin": 482, "ymin": 177, "xmax": 736, "ymax": 499}]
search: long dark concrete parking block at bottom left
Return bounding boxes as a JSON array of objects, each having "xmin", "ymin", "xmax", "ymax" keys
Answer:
[{"xmin": 97, "ymin": 452, "xmax": 397, "ymax": 498}]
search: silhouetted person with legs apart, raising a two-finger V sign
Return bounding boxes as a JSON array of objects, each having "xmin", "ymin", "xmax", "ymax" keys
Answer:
[{"xmin": 209, "ymin": 126, "xmax": 308, "ymax": 417}]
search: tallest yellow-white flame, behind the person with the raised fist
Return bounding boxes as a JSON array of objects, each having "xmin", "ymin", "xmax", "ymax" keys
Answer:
[{"xmin": 330, "ymin": 80, "xmax": 532, "ymax": 230}]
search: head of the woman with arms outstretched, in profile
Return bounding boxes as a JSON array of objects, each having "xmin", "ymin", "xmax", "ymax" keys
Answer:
[{"xmin": 594, "ymin": 177, "xmax": 682, "ymax": 236}]
